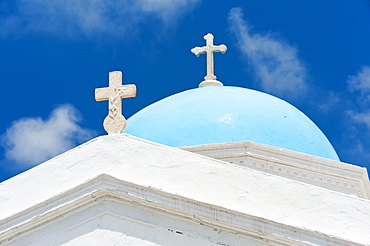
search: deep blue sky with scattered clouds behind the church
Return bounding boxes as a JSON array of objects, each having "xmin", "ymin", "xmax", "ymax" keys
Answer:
[{"xmin": 0, "ymin": 0, "xmax": 370, "ymax": 181}]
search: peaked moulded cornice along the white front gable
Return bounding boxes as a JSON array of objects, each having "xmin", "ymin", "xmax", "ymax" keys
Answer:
[{"xmin": 0, "ymin": 174, "xmax": 360, "ymax": 245}]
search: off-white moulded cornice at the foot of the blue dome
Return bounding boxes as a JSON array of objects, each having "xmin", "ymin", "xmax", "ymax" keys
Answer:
[{"xmin": 180, "ymin": 141, "xmax": 370, "ymax": 199}]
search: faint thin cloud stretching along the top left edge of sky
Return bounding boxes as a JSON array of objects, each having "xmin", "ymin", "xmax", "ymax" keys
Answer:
[{"xmin": 0, "ymin": 0, "xmax": 198, "ymax": 37}]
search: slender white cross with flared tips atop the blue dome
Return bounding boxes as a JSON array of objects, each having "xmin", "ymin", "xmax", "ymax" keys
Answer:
[{"xmin": 191, "ymin": 33, "xmax": 227, "ymax": 87}]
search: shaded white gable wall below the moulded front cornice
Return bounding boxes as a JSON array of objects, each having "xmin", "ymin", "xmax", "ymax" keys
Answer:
[{"xmin": 2, "ymin": 193, "xmax": 268, "ymax": 246}]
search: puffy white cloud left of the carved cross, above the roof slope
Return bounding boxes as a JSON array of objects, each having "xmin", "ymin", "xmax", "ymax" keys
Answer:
[{"xmin": 1, "ymin": 104, "xmax": 94, "ymax": 167}]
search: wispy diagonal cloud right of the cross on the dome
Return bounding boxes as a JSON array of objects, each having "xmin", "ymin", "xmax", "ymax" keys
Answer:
[{"xmin": 228, "ymin": 8, "xmax": 307, "ymax": 98}]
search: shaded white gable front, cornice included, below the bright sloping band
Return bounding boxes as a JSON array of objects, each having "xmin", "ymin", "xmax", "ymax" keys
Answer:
[{"xmin": 0, "ymin": 175, "xmax": 366, "ymax": 246}]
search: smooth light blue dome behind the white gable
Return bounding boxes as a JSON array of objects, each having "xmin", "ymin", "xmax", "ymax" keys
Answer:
[{"xmin": 125, "ymin": 86, "xmax": 339, "ymax": 160}]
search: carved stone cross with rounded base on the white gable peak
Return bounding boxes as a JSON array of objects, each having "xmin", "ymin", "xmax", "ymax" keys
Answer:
[{"xmin": 95, "ymin": 71, "xmax": 136, "ymax": 134}]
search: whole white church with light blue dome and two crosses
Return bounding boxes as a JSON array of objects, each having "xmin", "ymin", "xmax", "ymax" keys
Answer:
[{"xmin": 0, "ymin": 34, "xmax": 370, "ymax": 246}]
